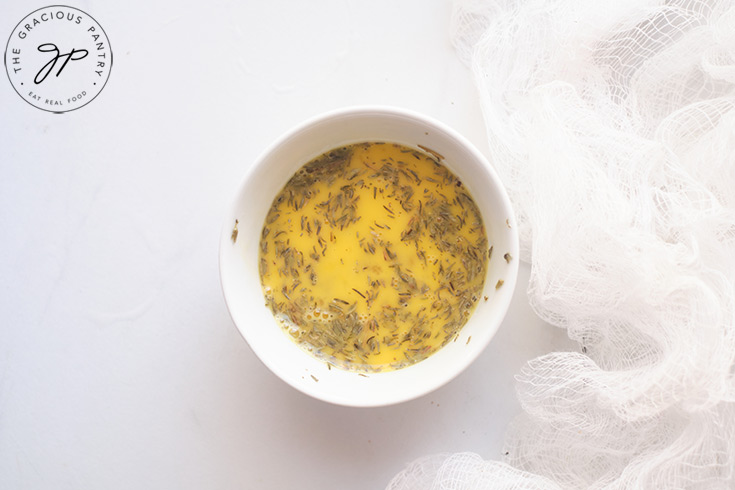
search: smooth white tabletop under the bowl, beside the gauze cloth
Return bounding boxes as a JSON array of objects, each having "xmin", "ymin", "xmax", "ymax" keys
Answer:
[{"xmin": 0, "ymin": 0, "xmax": 569, "ymax": 489}]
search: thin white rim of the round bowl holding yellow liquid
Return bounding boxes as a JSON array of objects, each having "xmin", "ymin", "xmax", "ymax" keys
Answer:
[{"xmin": 218, "ymin": 105, "xmax": 520, "ymax": 407}]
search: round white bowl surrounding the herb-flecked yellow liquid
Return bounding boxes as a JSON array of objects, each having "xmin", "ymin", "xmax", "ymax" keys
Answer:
[{"xmin": 219, "ymin": 106, "xmax": 518, "ymax": 407}]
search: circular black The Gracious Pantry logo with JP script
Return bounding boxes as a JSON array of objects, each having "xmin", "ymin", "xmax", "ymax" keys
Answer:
[{"xmin": 3, "ymin": 5, "xmax": 113, "ymax": 114}]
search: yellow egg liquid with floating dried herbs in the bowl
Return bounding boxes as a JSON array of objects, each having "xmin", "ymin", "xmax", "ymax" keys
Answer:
[{"xmin": 260, "ymin": 143, "xmax": 488, "ymax": 372}]
